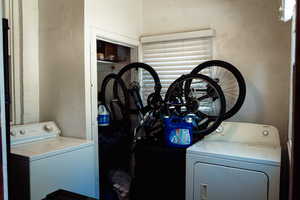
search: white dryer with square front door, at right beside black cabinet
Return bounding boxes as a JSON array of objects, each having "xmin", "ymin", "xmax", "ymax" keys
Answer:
[{"xmin": 186, "ymin": 122, "xmax": 281, "ymax": 200}]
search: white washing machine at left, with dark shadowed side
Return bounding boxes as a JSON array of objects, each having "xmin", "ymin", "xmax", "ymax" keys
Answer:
[{"xmin": 10, "ymin": 122, "xmax": 96, "ymax": 200}]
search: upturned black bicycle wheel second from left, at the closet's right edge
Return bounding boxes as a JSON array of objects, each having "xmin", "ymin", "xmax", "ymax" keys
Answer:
[{"xmin": 113, "ymin": 62, "xmax": 162, "ymax": 113}]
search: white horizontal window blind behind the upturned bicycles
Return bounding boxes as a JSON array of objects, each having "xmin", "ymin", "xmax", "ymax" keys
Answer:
[{"xmin": 141, "ymin": 31, "xmax": 213, "ymax": 100}]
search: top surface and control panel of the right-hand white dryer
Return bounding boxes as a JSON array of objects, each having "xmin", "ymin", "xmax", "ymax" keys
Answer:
[{"xmin": 187, "ymin": 122, "xmax": 281, "ymax": 166}]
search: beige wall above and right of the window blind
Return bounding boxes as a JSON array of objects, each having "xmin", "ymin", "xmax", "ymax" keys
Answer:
[{"xmin": 142, "ymin": 0, "xmax": 291, "ymax": 140}]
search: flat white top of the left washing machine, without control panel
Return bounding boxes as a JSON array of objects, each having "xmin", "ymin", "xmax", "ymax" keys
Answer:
[{"xmin": 11, "ymin": 136, "xmax": 93, "ymax": 161}]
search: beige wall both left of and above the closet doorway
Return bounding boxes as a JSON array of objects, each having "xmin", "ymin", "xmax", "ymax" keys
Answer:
[{"xmin": 39, "ymin": 0, "xmax": 142, "ymax": 137}]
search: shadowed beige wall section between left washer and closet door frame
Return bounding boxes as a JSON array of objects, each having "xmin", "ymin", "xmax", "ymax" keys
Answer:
[{"xmin": 39, "ymin": 0, "xmax": 86, "ymax": 138}]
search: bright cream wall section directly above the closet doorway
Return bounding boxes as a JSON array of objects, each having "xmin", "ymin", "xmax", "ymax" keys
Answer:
[{"xmin": 85, "ymin": 0, "xmax": 142, "ymax": 40}]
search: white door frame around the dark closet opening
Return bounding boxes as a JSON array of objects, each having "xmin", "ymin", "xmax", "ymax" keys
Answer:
[{"xmin": 85, "ymin": 27, "xmax": 140, "ymax": 197}]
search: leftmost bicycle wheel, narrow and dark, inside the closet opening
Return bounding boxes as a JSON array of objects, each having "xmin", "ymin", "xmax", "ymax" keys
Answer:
[{"xmin": 99, "ymin": 73, "xmax": 129, "ymax": 119}]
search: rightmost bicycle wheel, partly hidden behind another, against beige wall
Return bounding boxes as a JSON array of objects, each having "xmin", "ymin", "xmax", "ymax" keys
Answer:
[{"xmin": 191, "ymin": 60, "xmax": 246, "ymax": 120}]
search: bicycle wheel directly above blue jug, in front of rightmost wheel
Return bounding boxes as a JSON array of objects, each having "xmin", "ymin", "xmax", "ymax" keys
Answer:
[{"xmin": 165, "ymin": 74, "xmax": 226, "ymax": 135}]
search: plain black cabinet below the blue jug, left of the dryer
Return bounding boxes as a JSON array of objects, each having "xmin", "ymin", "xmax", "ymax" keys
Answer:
[{"xmin": 134, "ymin": 142, "xmax": 186, "ymax": 200}]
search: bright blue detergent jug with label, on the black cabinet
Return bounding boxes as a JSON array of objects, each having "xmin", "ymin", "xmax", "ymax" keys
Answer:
[{"xmin": 164, "ymin": 116, "xmax": 193, "ymax": 148}]
